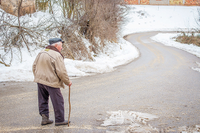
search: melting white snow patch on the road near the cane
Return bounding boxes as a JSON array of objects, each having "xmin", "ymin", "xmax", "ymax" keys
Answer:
[{"xmin": 101, "ymin": 110, "xmax": 158, "ymax": 133}]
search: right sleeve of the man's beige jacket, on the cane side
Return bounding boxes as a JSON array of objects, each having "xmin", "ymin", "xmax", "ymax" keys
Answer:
[{"xmin": 55, "ymin": 56, "xmax": 70, "ymax": 85}]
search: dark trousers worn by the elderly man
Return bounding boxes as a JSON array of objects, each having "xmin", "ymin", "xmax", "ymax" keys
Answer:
[{"xmin": 37, "ymin": 83, "xmax": 65, "ymax": 122}]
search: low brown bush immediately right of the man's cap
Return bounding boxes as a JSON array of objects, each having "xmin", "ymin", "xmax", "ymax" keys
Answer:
[{"xmin": 50, "ymin": 16, "xmax": 92, "ymax": 60}]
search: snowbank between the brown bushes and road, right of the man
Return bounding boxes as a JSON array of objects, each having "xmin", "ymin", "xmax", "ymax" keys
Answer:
[{"xmin": 65, "ymin": 38, "xmax": 139, "ymax": 77}]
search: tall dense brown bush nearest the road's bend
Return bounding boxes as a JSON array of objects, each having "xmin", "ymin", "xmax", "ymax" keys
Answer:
[{"xmin": 79, "ymin": 0, "xmax": 124, "ymax": 53}]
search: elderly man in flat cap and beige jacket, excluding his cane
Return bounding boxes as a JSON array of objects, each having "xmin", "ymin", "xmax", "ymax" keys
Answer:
[{"xmin": 32, "ymin": 38, "xmax": 72, "ymax": 126}]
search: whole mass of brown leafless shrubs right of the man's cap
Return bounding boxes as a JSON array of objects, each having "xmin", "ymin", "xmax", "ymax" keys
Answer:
[{"xmin": 58, "ymin": 0, "xmax": 124, "ymax": 60}]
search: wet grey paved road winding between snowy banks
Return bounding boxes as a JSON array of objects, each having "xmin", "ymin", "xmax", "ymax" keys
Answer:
[{"xmin": 0, "ymin": 32, "xmax": 200, "ymax": 133}]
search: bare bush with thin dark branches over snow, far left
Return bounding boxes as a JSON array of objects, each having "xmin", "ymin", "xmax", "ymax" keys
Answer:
[{"xmin": 0, "ymin": 0, "xmax": 47, "ymax": 66}]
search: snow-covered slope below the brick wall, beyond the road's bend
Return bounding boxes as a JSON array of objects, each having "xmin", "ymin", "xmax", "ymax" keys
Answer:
[{"xmin": 121, "ymin": 5, "xmax": 199, "ymax": 35}]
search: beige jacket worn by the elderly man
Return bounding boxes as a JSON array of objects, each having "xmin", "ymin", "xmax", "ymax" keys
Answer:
[{"xmin": 32, "ymin": 49, "xmax": 70, "ymax": 88}]
